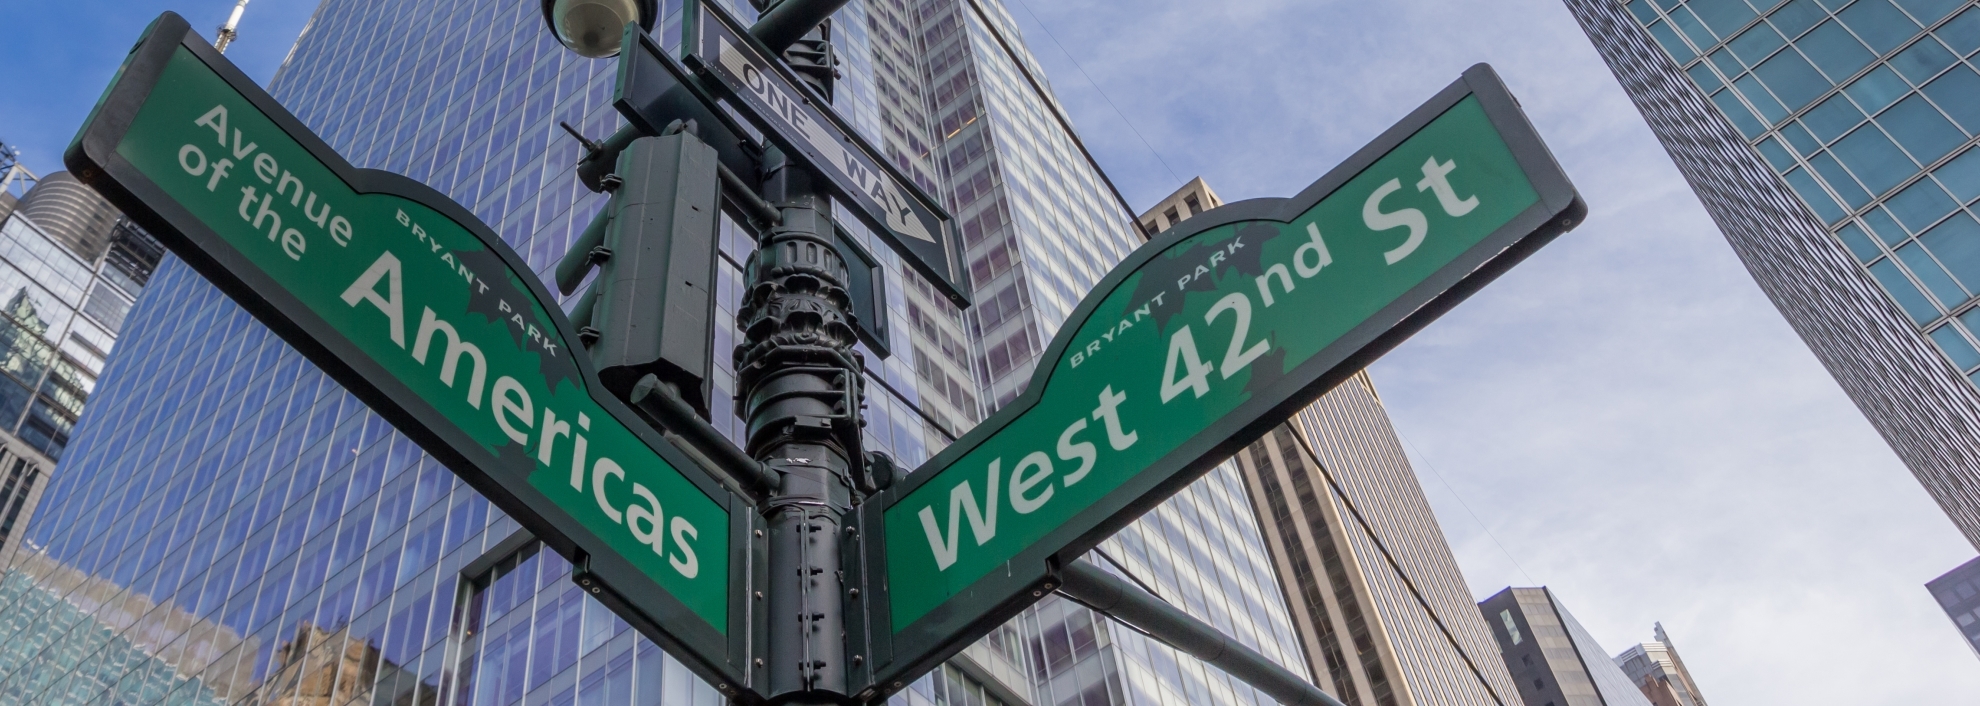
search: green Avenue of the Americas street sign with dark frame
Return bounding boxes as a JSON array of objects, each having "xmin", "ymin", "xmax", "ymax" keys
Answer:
[{"xmin": 65, "ymin": 14, "xmax": 756, "ymax": 694}]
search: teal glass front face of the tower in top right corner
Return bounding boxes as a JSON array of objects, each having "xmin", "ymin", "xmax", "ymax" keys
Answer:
[{"xmin": 1628, "ymin": 0, "xmax": 1980, "ymax": 377}]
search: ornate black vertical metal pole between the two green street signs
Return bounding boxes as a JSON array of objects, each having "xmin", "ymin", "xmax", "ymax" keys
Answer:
[{"xmin": 735, "ymin": 141, "xmax": 863, "ymax": 704}]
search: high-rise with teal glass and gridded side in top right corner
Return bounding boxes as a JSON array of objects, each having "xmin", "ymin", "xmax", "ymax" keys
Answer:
[{"xmin": 1566, "ymin": 0, "xmax": 1980, "ymax": 548}]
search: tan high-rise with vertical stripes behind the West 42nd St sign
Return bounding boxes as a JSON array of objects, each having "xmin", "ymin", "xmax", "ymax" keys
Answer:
[{"xmin": 1137, "ymin": 176, "xmax": 1515, "ymax": 706}]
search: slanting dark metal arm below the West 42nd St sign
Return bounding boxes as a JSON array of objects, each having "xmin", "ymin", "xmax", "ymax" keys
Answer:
[{"xmin": 1059, "ymin": 562, "xmax": 1340, "ymax": 706}]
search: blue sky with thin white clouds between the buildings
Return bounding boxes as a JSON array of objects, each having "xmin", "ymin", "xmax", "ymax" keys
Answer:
[{"xmin": 0, "ymin": 0, "xmax": 1980, "ymax": 704}]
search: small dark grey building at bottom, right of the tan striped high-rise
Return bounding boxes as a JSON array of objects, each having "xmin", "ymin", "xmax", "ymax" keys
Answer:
[{"xmin": 1479, "ymin": 587, "xmax": 1649, "ymax": 706}]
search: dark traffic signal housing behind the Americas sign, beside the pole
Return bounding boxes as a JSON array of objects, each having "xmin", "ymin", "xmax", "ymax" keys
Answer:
[{"xmin": 556, "ymin": 131, "xmax": 721, "ymax": 419}]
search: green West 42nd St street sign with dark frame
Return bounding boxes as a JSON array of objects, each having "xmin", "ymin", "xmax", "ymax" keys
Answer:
[{"xmin": 861, "ymin": 65, "xmax": 1586, "ymax": 692}]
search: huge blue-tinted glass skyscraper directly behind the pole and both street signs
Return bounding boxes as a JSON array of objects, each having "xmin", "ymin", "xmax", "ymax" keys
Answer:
[{"xmin": 0, "ymin": 0, "xmax": 1303, "ymax": 706}]
